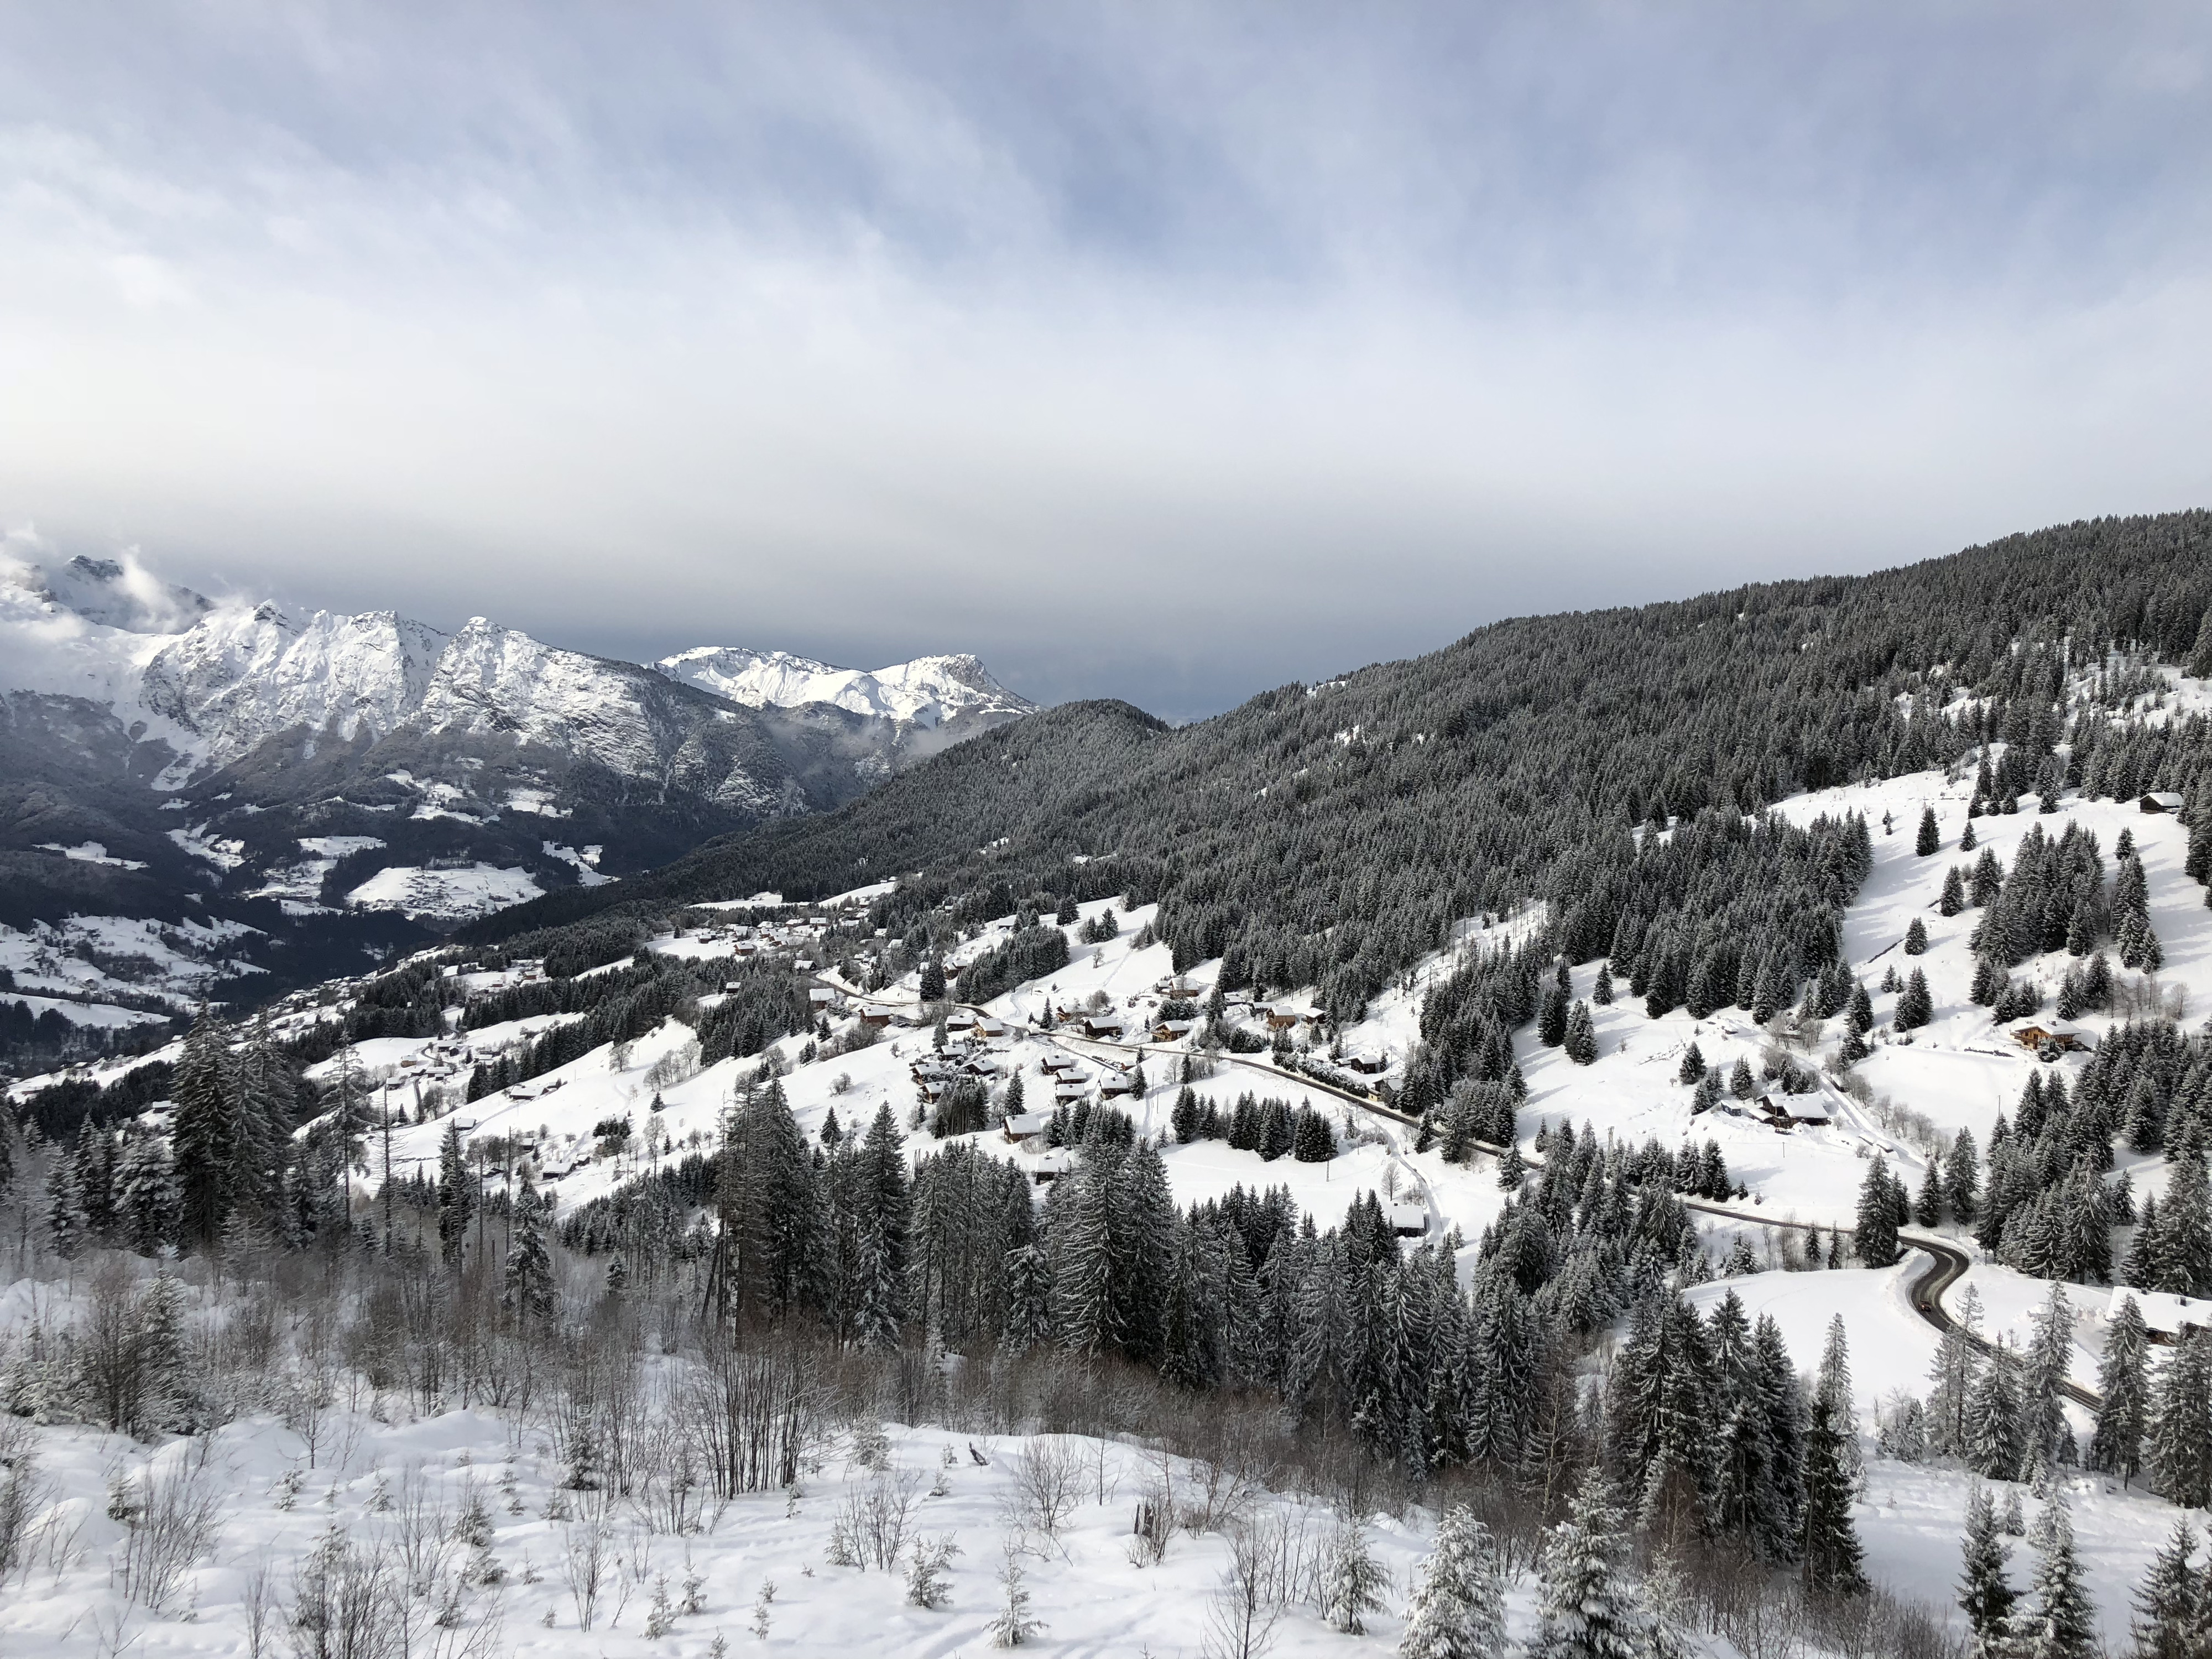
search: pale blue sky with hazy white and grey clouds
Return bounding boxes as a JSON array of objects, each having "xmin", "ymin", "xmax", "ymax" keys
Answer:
[{"xmin": 0, "ymin": 0, "xmax": 2212, "ymax": 719}]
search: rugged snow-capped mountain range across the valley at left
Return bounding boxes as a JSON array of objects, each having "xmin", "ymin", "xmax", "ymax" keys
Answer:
[{"xmin": 0, "ymin": 555, "xmax": 1031, "ymax": 1009}]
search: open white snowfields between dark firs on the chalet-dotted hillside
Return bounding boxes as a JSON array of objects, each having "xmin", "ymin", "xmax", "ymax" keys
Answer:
[{"xmin": 242, "ymin": 774, "xmax": 2212, "ymax": 1637}]
